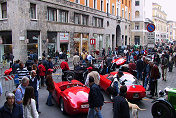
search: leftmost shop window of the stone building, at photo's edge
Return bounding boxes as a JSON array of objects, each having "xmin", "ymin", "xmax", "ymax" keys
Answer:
[{"xmin": 0, "ymin": 31, "xmax": 12, "ymax": 62}]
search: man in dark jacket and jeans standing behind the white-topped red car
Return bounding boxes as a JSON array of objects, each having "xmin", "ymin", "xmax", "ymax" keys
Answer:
[{"xmin": 136, "ymin": 56, "xmax": 143, "ymax": 80}]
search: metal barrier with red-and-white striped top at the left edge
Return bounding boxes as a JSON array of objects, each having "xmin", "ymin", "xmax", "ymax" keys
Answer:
[{"xmin": 0, "ymin": 75, "xmax": 16, "ymax": 95}]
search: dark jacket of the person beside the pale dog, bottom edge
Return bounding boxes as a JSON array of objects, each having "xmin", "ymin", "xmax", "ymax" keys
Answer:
[{"xmin": 113, "ymin": 96, "xmax": 130, "ymax": 118}]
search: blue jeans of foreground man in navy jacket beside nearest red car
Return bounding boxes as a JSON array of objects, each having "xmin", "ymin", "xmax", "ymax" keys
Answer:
[{"xmin": 87, "ymin": 107, "xmax": 103, "ymax": 118}]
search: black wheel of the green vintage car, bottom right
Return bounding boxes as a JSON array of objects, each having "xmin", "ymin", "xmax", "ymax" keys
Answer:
[{"xmin": 152, "ymin": 102, "xmax": 173, "ymax": 118}]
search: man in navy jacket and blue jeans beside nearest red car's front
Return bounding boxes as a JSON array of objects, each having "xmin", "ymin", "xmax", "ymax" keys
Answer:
[{"xmin": 87, "ymin": 76, "xmax": 104, "ymax": 118}]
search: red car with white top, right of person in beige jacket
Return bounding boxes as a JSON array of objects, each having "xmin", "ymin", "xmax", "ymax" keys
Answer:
[{"xmin": 100, "ymin": 72, "xmax": 146, "ymax": 100}]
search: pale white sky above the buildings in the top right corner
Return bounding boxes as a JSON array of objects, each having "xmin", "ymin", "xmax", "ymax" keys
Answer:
[{"xmin": 153, "ymin": 0, "xmax": 176, "ymax": 21}]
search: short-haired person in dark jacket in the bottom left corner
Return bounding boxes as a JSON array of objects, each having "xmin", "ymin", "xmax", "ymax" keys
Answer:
[{"xmin": 0, "ymin": 93, "xmax": 23, "ymax": 118}]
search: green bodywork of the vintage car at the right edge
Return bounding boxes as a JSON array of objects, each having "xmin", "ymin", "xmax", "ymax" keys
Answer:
[{"xmin": 168, "ymin": 88, "xmax": 176, "ymax": 110}]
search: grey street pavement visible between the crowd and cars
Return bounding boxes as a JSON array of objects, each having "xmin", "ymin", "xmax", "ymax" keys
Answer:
[{"xmin": 0, "ymin": 63, "xmax": 176, "ymax": 118}]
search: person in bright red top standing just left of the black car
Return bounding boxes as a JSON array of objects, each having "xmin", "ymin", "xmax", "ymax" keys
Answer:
[{"xmin": 60, "ymin": 59, "xmax": 70, "ymax": 81}]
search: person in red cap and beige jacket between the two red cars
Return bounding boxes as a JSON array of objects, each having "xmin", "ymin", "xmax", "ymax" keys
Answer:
[{"xmin": 85, "ymin": 66, "xmax": 100, "ymax": 86}]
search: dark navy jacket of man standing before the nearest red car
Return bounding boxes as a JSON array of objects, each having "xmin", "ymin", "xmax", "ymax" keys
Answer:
[{"xmin": 88, "ymin": 83, "xmax": 104, "ymax": 108}]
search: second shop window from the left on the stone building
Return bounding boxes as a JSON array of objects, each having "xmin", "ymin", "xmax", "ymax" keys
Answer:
[{"xmin": 27, "ymin": 31, "xmax": 40, "ymax": 59}]
